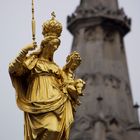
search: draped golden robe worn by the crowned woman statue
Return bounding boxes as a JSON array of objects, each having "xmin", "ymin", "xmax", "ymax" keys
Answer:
[{"xmin": 9, "ymin": 55, "xmax": 73, "ymax": 140}]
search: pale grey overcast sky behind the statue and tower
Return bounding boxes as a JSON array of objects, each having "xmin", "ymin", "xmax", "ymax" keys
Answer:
[{"xmin": 0, "ymin": 0, "xmax": 140, "ymax": 140}]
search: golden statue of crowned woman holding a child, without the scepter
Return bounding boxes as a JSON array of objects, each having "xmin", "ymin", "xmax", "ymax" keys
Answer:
[{"xmin": 9, "ymin": 13, "xmax": 85, "ymax": 140}]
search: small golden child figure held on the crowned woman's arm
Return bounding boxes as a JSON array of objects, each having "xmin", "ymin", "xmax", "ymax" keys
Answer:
[{"xmin": 62, "ymin": 51, "xmax": 85, "ymax": 110}]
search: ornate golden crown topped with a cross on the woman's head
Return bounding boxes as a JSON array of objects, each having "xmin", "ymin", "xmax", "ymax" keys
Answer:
[{"xmin": 42, "ymin": 12, "xmax": 62, "ymax": 37}]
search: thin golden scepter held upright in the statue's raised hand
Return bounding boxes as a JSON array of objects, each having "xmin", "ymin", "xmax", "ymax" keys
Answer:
[{"xmin": 32, "ymin": 0, "xmax": 37, "ymax": 47}]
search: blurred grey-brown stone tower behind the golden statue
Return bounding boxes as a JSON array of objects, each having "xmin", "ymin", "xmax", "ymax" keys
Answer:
[{"xmin": 67, "ymin": 0, "xmax": 140, "ymax": 140}]
